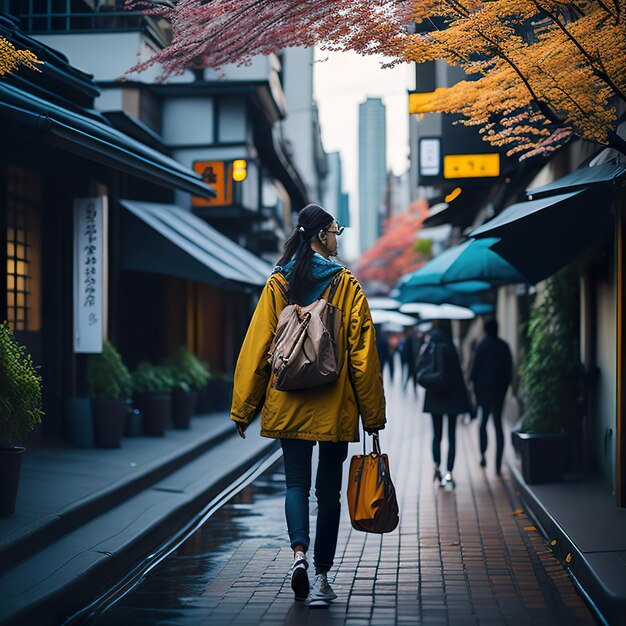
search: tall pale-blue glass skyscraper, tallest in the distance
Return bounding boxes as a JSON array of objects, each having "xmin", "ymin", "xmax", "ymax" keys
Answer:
[{"xmin": 359, "ymin": 98, "xmax": 387, "ymax": 252}]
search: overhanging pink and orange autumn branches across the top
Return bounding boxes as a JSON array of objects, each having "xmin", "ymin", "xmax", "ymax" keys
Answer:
[{"xmin": 127, "ymin": 0, "xmax": 626, "ymax": 157}]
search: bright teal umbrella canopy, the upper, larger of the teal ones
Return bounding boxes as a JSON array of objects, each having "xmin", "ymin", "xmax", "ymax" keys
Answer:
[{"xmin": 403, "ymin": 238, "xmax": 526, "ymax": 291}]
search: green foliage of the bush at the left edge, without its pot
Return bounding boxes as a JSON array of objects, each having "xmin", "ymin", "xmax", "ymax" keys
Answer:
[{"xmin": 0, "ymin": 322, "xmax": 43, "ymax": 445}]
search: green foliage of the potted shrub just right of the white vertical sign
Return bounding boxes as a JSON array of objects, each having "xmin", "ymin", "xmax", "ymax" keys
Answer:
[{"xmin": 87, "ymin": 339, "xmax": 133, "ymax": 400}]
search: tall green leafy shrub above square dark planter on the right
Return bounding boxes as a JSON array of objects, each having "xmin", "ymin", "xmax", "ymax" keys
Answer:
[{"xmin": 521, "ymin": 267, "xmax": 584, "ymax": 433}]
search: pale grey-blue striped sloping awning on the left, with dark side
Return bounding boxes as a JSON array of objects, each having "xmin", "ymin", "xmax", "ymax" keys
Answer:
[{"xmin": 120, "ymin": 200, "xmax": 272, "ymax": 288}]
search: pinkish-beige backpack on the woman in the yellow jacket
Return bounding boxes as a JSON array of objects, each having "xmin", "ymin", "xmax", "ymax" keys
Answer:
[{"xmin": 268, "ymin": 276, "xmax": 343, "ymax": 391}]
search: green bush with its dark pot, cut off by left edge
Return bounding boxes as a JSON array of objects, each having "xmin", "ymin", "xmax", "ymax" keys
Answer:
[{"xmin": 0, "ymin": 322, "xmax": 43, "ymax": 517}]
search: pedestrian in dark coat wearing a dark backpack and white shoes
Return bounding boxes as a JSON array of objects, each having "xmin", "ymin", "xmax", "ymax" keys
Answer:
[{"xmin": 417, "ymin": 320, "xmax": 470, "ymax": 490}]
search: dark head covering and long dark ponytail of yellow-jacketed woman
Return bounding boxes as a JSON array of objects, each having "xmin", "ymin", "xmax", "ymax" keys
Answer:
[{"xmin": 278, "ymin": 204, "xmax": 335, "ymax": 303}]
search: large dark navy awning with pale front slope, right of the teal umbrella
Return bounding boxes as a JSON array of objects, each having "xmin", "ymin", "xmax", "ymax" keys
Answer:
[{"xmin": 471, "ymin": 187, "xmax": 610, "ymax": 283}]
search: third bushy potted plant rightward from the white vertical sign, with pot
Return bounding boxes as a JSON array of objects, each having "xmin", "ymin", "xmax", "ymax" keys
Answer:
[{"xmin": 169, "ymin": 346, "xmax": 210, "ymax": 428}]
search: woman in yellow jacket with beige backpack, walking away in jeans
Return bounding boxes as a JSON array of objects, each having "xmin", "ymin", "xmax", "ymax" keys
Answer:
[{"xmin": 230, "ymin": 204, "xmax": 386, "ymax": 607}]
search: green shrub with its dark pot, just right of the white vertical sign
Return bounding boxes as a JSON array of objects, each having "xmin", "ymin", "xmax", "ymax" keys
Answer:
[{"xmin": 87, "ymin": 340, "xmax": 132, "ymax": 448}]
